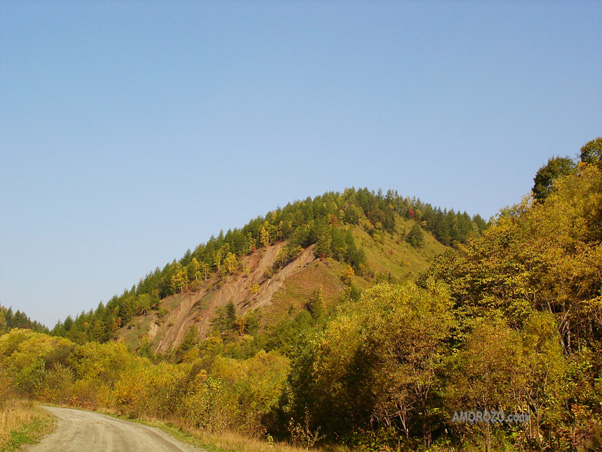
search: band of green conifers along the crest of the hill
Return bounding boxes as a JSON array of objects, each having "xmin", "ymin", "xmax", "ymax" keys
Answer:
[{"xmin": 52, "ymin": 189, "xmax": 487, "ymax": 343}]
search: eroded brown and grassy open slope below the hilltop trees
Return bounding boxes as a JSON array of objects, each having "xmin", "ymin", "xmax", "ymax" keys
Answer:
[{"xmin": 118, "ymin": 217, "xmax": 446, "ymax": 354}]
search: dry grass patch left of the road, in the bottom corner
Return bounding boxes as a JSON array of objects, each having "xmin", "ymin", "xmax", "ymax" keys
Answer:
[{"xmin": 0, "ymin": 399, "xmax": 54, "ymax": 452}]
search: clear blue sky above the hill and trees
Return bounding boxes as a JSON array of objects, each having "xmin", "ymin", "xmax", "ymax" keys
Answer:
[{"xmin": 0, "ymin": 0, "xmax": 602, "ymax": 326}]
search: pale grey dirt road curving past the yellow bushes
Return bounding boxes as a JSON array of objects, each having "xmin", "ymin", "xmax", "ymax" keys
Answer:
[{"xmin": 25, "ymin": 407, "xmax": 206, "ymax": 452}]
